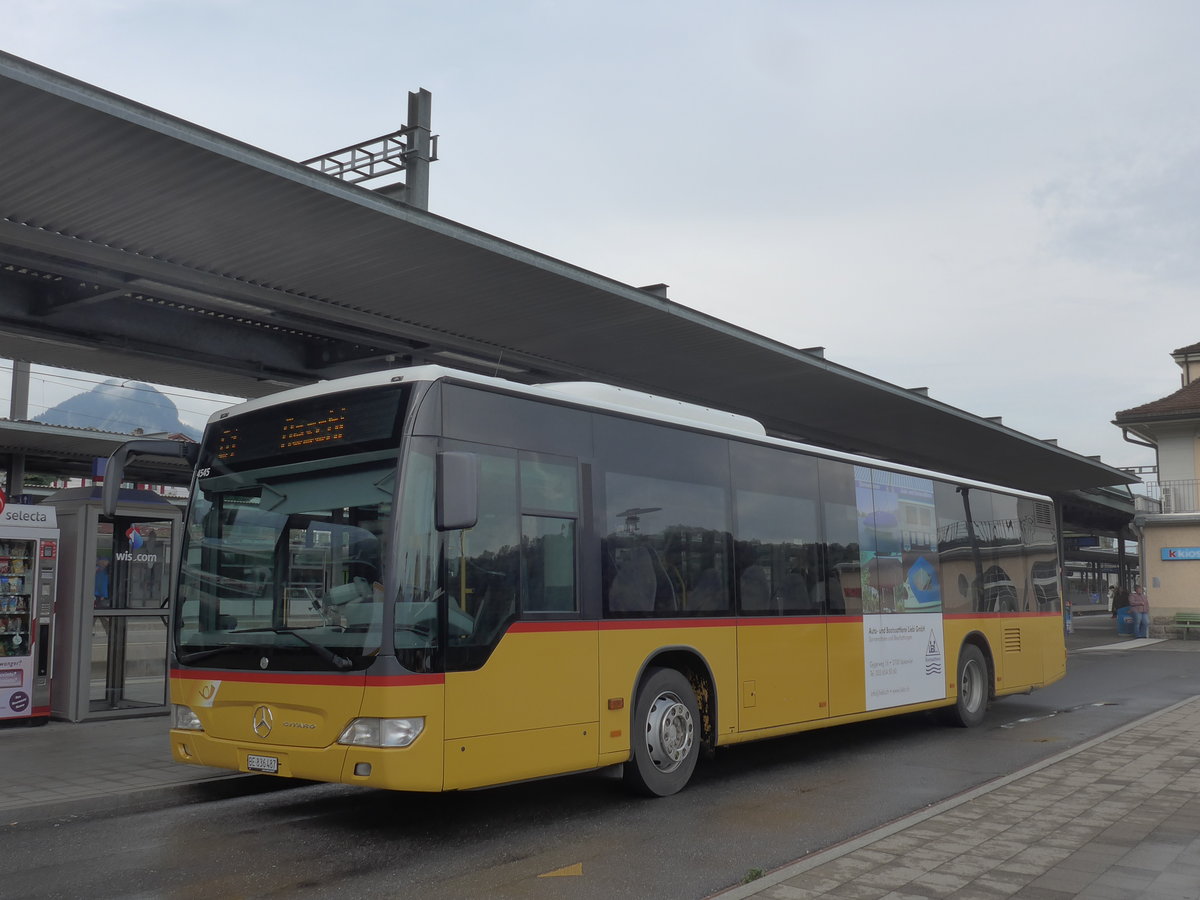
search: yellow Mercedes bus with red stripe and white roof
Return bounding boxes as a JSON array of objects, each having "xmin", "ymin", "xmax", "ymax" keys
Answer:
[{"xmin": 108, "ymin": 366, "xmax": 1066, "ymax": 796}]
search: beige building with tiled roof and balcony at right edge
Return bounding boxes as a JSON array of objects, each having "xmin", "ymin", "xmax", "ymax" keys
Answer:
[{"xmin": 1112, "ymin": 343, "xmax": 1200, "ymax": 634}]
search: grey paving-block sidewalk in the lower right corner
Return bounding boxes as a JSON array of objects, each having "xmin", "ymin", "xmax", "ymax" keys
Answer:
[{"xmin": 718, "ymin": 657, "xmax": 1200, "ymax": 900}]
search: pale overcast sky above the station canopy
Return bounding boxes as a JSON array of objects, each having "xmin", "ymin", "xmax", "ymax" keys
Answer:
[{"xmin": 0, "ymin": 0, "xmax": 1200, "ymax": 466}]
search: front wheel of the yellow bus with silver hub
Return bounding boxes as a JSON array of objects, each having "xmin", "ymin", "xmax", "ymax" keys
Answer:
[{"xmin": 624, "ymin": 668, "xmax": 700, "ymax": 797}]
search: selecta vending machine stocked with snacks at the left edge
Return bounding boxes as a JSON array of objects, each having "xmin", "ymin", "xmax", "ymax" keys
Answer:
[{"xmin": 0, "ymin": 491, "xmax": 59, "ymax": 724}]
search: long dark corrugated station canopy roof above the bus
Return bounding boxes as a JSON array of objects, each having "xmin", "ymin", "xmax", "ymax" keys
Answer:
[{"xmin": 0, "ymin": 53, "xmax": 1136, "ymax": 508}]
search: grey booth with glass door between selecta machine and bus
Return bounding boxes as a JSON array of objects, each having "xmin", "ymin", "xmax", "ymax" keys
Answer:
[{"xmin": 41, "ymin": 487, "xmax": 182, "ymax": 722}]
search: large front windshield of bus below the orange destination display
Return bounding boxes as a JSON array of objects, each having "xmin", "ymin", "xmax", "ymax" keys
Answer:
[{"xmin": 175, "ymin": 452, "xmax": 396, "ymax": 671}]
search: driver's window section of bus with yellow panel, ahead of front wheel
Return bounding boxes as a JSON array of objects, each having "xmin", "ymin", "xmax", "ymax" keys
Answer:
[{"xmin": 444, "ymin": 446, "xmax": 599, "ymax": 790}]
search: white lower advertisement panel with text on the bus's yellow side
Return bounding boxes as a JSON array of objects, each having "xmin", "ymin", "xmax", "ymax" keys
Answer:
[{"xmin": 863, "ymin": 613, "xmax": 946, "ymax": 709}]
